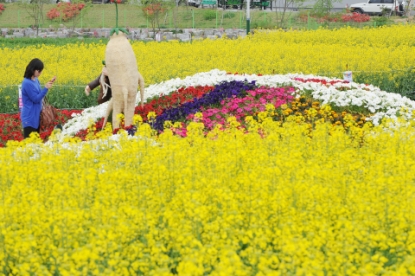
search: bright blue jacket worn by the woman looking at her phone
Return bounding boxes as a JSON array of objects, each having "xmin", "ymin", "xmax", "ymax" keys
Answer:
[{"xmin": 20, "ymin": 78, "xmax": 48, "ymax": 128}]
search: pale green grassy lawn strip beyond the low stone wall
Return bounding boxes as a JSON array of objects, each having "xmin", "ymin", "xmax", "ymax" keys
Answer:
[{"xmin": 0, "ymin": 3, "xmax": 410, "ymax": 29}]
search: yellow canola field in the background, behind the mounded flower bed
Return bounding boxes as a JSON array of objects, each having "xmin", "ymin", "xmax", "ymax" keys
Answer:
[{"xmin": 0, "ymin": 25, "xmax": 415, "ymax": 86}]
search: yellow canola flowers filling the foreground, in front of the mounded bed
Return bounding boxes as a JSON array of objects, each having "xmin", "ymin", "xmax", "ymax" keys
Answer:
[{"xmin": 0, "ymin": 117, "xmax": 415, "ymax": 275}]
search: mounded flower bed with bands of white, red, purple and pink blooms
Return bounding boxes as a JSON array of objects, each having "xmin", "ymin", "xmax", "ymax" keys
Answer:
[{"xmin": 62, "ymin": 70, "xmax": 415, "ymax": 139}]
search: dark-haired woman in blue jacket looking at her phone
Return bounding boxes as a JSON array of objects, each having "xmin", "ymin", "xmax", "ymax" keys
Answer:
[{"xmin": 20, "ymin": 58, "xmax": 55, "ymax": 138}]
